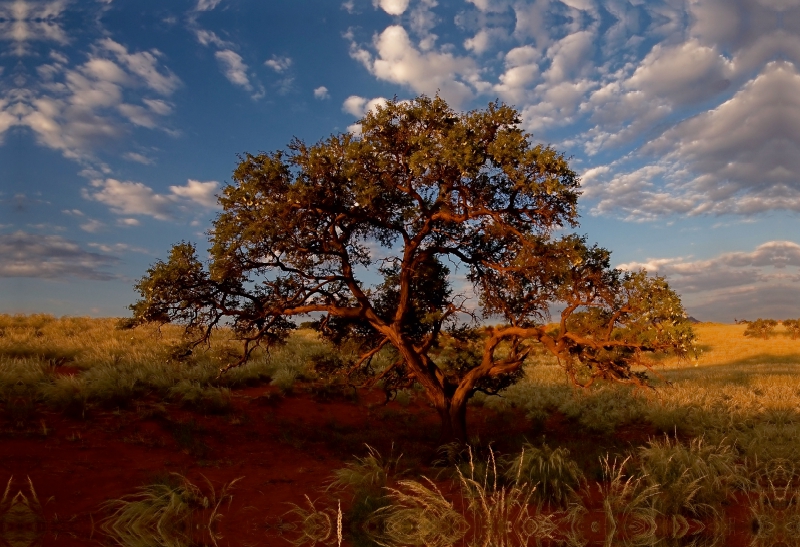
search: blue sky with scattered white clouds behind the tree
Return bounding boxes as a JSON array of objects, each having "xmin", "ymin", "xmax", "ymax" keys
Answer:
[{"xmin": 0, "ymin": 0, "xmax": 800, "ymax": 322}]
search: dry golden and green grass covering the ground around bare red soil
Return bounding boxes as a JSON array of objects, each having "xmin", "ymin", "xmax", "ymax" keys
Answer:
[{"xmin": 0, "ymin": 316, "xmax": 800, "ymax": 546}]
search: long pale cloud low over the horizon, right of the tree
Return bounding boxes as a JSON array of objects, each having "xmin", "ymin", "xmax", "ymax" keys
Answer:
[{"xmin": 619, "ymin": 241, "xmax": 800, "ymax": 321}]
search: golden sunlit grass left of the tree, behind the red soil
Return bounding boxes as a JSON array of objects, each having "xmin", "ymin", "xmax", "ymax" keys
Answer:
[{"xmin": 0, "ymin": 315, "xmax": 329, "ymax": 417}]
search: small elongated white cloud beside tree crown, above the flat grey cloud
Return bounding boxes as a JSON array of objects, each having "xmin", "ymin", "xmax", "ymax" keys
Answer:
[{"xmin": 83, "ymin": 178, "xmax": 219, "ymax": 218}]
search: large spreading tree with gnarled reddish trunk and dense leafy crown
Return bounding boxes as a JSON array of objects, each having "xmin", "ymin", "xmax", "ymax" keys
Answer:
[{"xmin": 131, "ymin": 97, "xmax": 693, "ymax": 440}]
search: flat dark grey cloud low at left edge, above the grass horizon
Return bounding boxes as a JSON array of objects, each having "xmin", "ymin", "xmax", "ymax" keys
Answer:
[{"xmin": 0, "ymin": 231, "xmax": 119, "ymax": 281}]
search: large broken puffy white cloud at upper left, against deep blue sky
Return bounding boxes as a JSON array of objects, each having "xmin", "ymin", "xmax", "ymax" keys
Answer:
[{"xmin": 0, "ymin": 38, "xmax": 181, "ymax": 160}]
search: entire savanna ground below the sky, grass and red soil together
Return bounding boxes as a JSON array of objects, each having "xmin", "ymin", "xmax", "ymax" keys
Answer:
[{"xmin": 0, "ymin": 316, "xmax": 800, "ymax": 547}]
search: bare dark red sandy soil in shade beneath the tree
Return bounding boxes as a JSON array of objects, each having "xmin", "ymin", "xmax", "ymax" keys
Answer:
[{"xmin": 0, "ymin": 384, "xmax": 751, "ymax": 546}]
